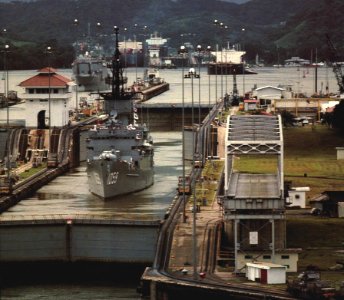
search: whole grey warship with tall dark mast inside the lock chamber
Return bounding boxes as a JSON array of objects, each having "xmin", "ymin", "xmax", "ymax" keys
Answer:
[{"xmin": 87, "ymin": 27, "xmax": 154, "ymax": 199}]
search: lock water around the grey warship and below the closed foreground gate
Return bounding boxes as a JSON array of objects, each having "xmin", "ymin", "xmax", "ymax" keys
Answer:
[{"xmin": 0, "ymin": 132, "xmax": 182, "ymax": 300}]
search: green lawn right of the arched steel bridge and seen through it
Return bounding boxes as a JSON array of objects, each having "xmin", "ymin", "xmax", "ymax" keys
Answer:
[{"xmin": 234, "ymin": 125, "xmax": 344, "ymax": 198}]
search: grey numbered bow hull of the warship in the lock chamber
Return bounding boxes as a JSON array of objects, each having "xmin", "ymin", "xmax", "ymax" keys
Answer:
[{"xmin": 87, "ymin": 157, "xmax": 154, "ymax": 199}]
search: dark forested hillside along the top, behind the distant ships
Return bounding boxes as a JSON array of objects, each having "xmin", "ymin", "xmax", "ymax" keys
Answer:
[{"xmin": 0, "ymin": 0, "xmax": 344, "ymax": 65}]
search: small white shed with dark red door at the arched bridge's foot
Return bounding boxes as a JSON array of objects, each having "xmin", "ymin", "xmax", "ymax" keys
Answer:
[{"xmin": 246, "ymin": 262, "xmax": 287, "ymax": 284}]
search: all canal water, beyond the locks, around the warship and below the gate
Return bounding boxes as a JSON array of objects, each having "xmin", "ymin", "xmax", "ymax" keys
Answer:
[{"xmin": 0, "ymin": 68, "xmax": 338, "ymax": 300}]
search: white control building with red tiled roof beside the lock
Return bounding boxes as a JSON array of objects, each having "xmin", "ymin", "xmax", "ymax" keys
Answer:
[{"xmin": 19, "ymin": 67, "xmax": 73, "ymax": 129}]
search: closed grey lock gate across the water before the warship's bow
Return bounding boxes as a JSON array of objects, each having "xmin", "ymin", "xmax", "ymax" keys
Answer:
[{"xmin": 0, "ymin": 224, "xmax": 158, "ymax": 263}]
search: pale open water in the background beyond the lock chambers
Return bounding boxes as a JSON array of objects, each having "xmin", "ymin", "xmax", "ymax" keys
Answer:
[{"xmin": 0, "ymin": 67, "xmax": 338, "ymax": 125}]
